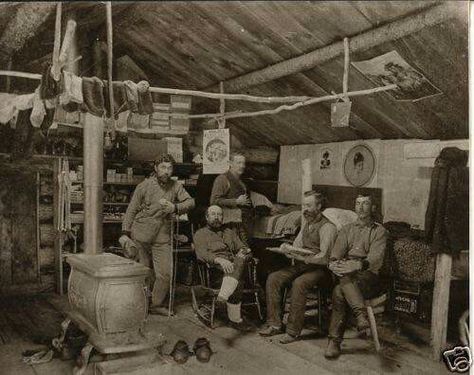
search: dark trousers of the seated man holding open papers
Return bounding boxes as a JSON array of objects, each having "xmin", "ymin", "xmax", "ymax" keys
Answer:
[{"xmin": 266, "ymin": 261, "xmax": 331, "ymax": 336}]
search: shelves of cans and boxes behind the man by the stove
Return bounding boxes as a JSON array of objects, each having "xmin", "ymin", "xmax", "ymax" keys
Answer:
[{"xmin": 58, "ymin": 158, "xmax": 201, "ymax": 293}]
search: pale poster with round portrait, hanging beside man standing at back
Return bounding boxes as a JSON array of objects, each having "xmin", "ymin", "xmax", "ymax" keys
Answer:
[{"xmin": 202, "ymin": 129, "xmax": 230, "ymax": 174}]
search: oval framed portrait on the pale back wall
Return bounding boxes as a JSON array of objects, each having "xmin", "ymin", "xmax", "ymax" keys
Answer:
[{"xmin": 344, "ymin": 144, "xmax": 376, "ymax": 186}]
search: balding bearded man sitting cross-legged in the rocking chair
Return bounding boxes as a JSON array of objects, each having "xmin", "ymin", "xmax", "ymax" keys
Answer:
[{"xmin": 194, "ymin": 206, "xmax": 252, "ymax": 331}]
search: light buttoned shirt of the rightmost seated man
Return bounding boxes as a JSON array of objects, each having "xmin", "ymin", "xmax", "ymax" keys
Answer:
[{"xmin": 330, "ymin": 220, "xmax": 387, "ymax": 274}]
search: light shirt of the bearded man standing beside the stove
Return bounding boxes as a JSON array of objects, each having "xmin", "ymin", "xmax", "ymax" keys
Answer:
[{"xmin": 122, "ymin": 176, "xmax": 194, "ymax": 232}]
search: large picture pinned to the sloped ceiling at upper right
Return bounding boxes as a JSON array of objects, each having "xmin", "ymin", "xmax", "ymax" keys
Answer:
[{"xmin": 352, "ymin": 51, "xmax": 442, "ymax": 102}]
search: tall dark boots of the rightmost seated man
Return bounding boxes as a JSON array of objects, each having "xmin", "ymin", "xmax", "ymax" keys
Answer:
[{"xmin": 324, "ymin": 282, "xmax": 370, "ymax": 359}]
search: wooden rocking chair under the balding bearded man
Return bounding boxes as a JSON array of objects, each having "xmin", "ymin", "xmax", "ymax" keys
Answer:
[{"xmin": 191, "ymin": 258, "xmax": 263, "ymax": 328}]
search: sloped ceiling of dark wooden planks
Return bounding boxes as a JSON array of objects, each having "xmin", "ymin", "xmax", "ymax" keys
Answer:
[{"xmin": 0, "ymin": 1, "xmax": 468, "ymax": 146}]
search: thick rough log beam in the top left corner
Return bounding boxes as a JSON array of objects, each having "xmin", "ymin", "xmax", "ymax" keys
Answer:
[{"xmin": 0, "ymin": 2, "xmax": 56, "ymax": 64}]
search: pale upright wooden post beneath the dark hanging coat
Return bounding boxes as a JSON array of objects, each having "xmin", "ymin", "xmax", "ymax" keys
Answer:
[{"xmin": 431, "ymin": 254, "xmax": 453, "ymax": 361}]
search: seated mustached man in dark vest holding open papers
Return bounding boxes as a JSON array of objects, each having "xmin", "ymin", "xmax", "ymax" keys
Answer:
[{"xmin": 260, "ymin": 191, "xmax": 337, "ymax": 344}]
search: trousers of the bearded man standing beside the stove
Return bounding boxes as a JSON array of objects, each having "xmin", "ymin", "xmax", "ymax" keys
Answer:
[{"xmin": 135, "ymin": 239, "xmax": 172, "ymax": 306}]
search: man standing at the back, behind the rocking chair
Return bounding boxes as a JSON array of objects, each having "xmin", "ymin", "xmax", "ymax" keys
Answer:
[{"xmin": 211, "ymin": 154, "xmax": 253, "ymax": 243}]
